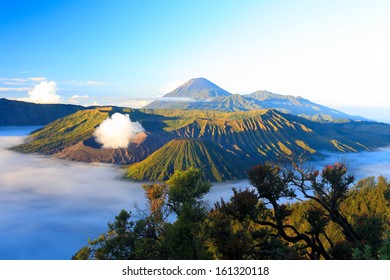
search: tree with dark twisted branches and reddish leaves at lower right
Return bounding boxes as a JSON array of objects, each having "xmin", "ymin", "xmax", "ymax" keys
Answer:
[{"xmin": 248, "ymin": 163, "xmax": 389, "ymax": 259}]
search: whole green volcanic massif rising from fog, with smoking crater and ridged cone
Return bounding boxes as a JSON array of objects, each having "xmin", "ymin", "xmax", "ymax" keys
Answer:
[{"xmin": 14, "ymin": 107, "xmax": 390, "ymax": 181}]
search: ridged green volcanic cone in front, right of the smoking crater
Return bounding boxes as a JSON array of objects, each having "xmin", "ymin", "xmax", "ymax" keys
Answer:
[{"xmin": 127, "ymin": 139, "xmax": 254, "ymax": 181}]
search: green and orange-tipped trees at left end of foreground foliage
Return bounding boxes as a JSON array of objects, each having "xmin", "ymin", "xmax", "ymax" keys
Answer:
[{"xmin": 73, "ymin": 168, "xmax": 210, "ymax": 260}]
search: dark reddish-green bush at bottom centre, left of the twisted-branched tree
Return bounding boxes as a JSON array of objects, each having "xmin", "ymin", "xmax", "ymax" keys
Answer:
[{"xmin": 207, "ymin": 188, "xmax": 297, "ymax": 260}]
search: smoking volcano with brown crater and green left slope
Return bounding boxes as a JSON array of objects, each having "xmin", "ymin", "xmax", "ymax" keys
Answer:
[{"xmin": 13, "ymin": 107, "xmax": 172, "ymax": 164}]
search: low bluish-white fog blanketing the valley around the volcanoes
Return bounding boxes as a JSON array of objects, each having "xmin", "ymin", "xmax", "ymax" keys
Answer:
[{"xmin": 0, "ymin": 127, "xmax": 390, "ymax": 259}]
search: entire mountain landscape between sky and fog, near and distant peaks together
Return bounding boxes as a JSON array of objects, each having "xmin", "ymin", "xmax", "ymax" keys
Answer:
[{"xmin": 0, "ymin": 78, "xmax": 390, "ymax": 181}]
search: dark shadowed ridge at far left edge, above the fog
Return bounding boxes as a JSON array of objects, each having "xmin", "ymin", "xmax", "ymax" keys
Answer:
[{"xmin": 0, "ymin": 98, "xmax": 86, "ymax": 126}]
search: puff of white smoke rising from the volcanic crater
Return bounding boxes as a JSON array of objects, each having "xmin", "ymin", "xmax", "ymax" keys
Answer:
[{"xmin": 94, "ymin": 113, "xmax": 145, "ymax": 149}]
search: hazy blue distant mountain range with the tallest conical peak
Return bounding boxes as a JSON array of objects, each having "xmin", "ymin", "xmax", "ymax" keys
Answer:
[{"xmin": 143, "ymin": 78, "xmax": 367, "ymax": 122}]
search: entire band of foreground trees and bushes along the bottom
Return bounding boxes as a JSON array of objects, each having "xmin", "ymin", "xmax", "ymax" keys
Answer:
[{"xmin": 73, "ymin": 163, "xmax": 390, "ymax": 259}]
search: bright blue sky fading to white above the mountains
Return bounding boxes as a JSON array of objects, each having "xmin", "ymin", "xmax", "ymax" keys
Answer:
[{"xmin": 0, "ymin": 0, "xmax": 390, "ymax": 120}]
